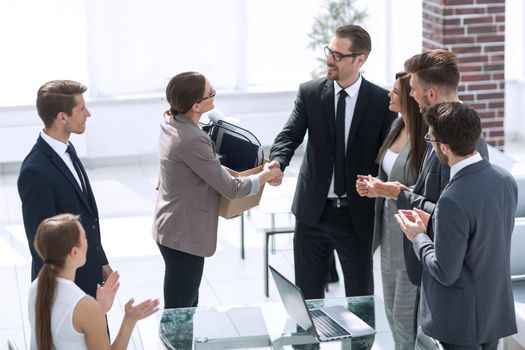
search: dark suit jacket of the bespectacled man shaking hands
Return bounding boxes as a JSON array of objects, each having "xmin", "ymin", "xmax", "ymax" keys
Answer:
[{"xmin": 270, "ymin": 78, "xmax": 396, "ymax": 235}]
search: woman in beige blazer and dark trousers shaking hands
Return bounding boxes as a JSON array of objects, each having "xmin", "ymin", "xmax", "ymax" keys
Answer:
[{"xmin": 153, "ymin": 72, "xmax": 282, "ymax": 308}]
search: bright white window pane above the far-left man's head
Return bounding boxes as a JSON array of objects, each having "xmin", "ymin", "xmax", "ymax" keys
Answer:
[{"xmin": 0, "ymin": 0, "xmax": 88, "ymax": 106}]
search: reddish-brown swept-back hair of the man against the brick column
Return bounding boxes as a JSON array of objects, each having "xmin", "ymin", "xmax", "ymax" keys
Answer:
[{"xmin": 405, "ymin": 49, "xmax": 459, "ymax": 91}]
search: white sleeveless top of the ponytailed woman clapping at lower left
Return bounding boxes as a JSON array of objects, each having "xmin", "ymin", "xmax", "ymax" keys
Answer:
[{"xmin": 28, "ymin": 278, "xmax": 88, "ymax": 350}]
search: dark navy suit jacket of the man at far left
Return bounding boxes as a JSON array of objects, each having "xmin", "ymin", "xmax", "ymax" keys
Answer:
[{"xmin": 18, "ymin": 136, "xmax": 108, "ymax": 297}]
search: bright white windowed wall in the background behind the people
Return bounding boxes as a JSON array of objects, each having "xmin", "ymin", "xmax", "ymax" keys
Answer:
[{"xmin": 0, "ymin": 0, "xmax": 525, "ymax": 163}]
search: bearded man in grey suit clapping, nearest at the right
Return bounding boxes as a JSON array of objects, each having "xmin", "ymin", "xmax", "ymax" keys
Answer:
[{"xmin": 396, "ymin": 102, "xmax": 518, "ymax": 350}]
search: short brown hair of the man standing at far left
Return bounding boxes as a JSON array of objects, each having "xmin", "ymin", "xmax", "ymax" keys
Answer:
[{"xmin": 36, "ymin": 80, "xmax": 87, "ymax": 128}]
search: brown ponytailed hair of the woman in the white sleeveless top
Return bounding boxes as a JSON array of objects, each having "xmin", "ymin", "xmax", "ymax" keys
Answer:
[{"xmin": 33, "ymin": 214, "xmax": 81, "ymax": 350}]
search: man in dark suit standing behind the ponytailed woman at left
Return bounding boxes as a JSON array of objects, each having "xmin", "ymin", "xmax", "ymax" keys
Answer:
[{"xmin": 18, "ymin": 80, "xmax": 112, "ymax": 297}]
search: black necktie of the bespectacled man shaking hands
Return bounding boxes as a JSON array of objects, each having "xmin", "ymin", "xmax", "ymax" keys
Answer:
[{"xmin": 334, "ymin": 90, "xmax": 348, "ymax": 197}]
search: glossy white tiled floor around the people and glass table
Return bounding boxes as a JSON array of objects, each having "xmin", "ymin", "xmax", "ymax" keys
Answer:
[{"xmin": 0, "ymin": 143, "xmax": 525, "ymax": 349}]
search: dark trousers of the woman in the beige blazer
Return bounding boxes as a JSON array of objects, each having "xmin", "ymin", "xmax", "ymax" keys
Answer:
[{"xmin": 157, "ymin": 244, "xmax": 204, "ymax": 309}]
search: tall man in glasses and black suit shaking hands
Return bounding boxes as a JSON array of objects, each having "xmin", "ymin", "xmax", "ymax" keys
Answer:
[{"xmin": 270, "ymin": 25, "xmax": 396, "ymax": 299}]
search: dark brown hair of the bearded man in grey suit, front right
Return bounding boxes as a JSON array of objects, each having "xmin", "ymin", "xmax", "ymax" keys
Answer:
[{"xmin": 425, "ymin": 102, "xmax": 481, "ymax": 157}]
